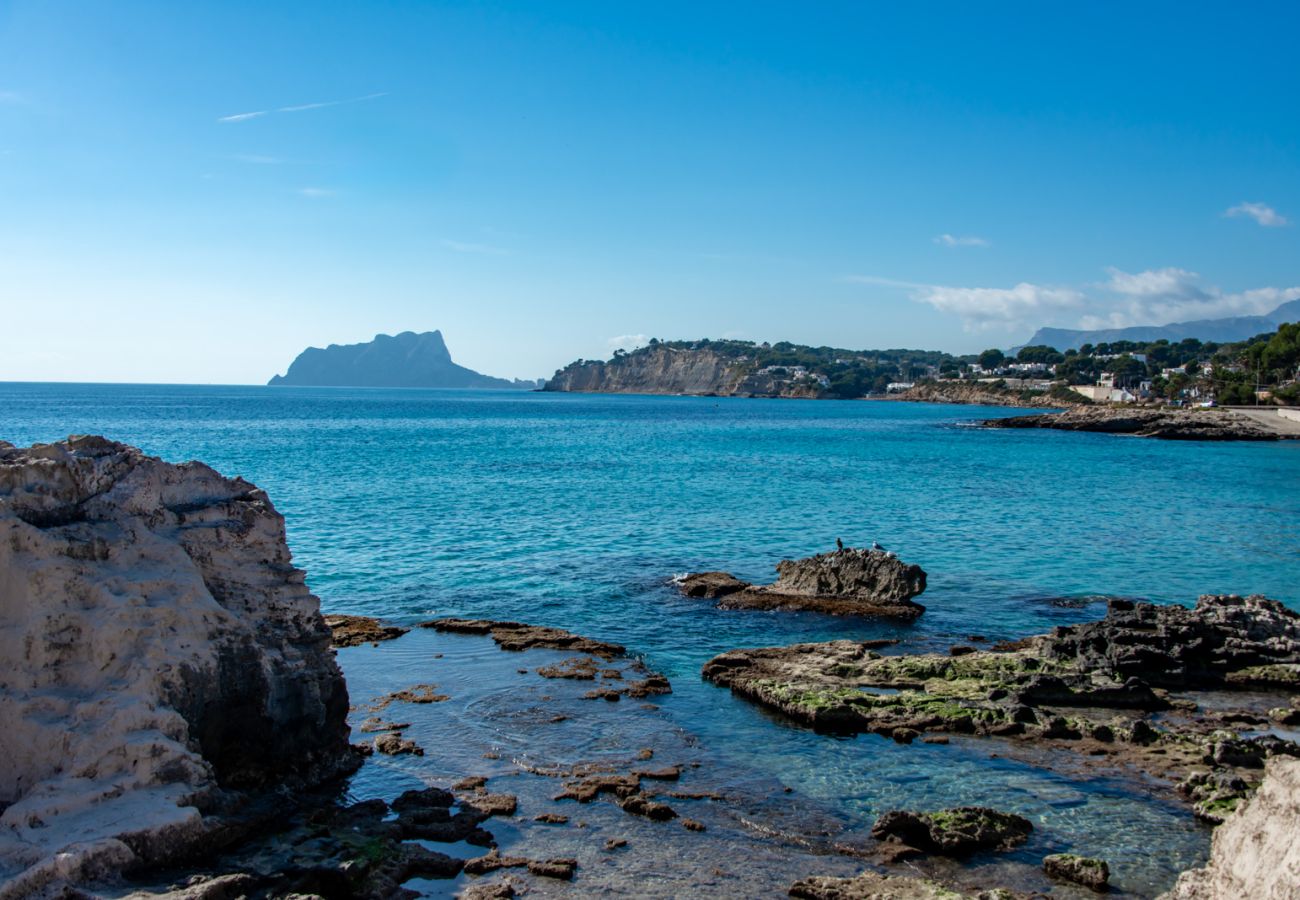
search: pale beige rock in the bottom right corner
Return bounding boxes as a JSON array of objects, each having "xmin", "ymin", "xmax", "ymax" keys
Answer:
[{"xmin": 1161, "ymin": 760, "xmax": 1300, "ymax": 900}]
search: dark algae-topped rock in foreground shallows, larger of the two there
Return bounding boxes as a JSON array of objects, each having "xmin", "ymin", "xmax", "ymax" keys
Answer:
[{"xmin": 871, "ymin": 806, "xmax": 1034, "ymax": 856}]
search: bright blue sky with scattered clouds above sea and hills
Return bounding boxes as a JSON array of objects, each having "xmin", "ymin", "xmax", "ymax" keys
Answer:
[{"xmin": 0, "ymin": 0, "xmax": 1300, "ymax": 382}]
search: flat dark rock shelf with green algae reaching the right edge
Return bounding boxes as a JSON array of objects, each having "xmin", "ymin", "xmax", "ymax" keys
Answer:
[{"xmin": 703, "ymin": 596, "xmax": 1300, "ymax": 822}]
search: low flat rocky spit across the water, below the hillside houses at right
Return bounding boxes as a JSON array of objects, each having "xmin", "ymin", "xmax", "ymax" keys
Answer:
[{"xmin": 982, "ymin": 406, "xmax": 1290, "ymax": 441}]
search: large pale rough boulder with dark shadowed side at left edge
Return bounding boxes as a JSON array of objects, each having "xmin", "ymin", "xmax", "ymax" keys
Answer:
[{"xmin": 0, "ymin": 437, "xmax": 355, "ymax": 897}]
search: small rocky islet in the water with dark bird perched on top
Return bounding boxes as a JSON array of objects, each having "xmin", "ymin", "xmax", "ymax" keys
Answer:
[{"xmin": 676, "ymin": 548, "xmax": 926, "ymax": 620}]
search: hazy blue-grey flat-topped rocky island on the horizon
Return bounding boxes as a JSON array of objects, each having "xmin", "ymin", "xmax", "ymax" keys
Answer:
[{"xmin": 267, "ymin": 332, "xmax": 538, "ymax": 390}]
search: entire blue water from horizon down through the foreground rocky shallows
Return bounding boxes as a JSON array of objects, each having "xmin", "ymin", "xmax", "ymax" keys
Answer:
[{"xmin": 0, "ymin": 385, "xmax": 1300, "ymax": 897}]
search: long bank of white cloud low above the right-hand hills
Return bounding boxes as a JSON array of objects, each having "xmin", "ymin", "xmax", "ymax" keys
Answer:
[{"xmin": 842, "ymin": 267, "xmax": 1300, "ymax": 332}]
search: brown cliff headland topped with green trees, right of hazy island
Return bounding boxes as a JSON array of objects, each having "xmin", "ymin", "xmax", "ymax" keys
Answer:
[{"xmin": 542, "ymin": 346, "xmax": 823, "ymax": 398}]
